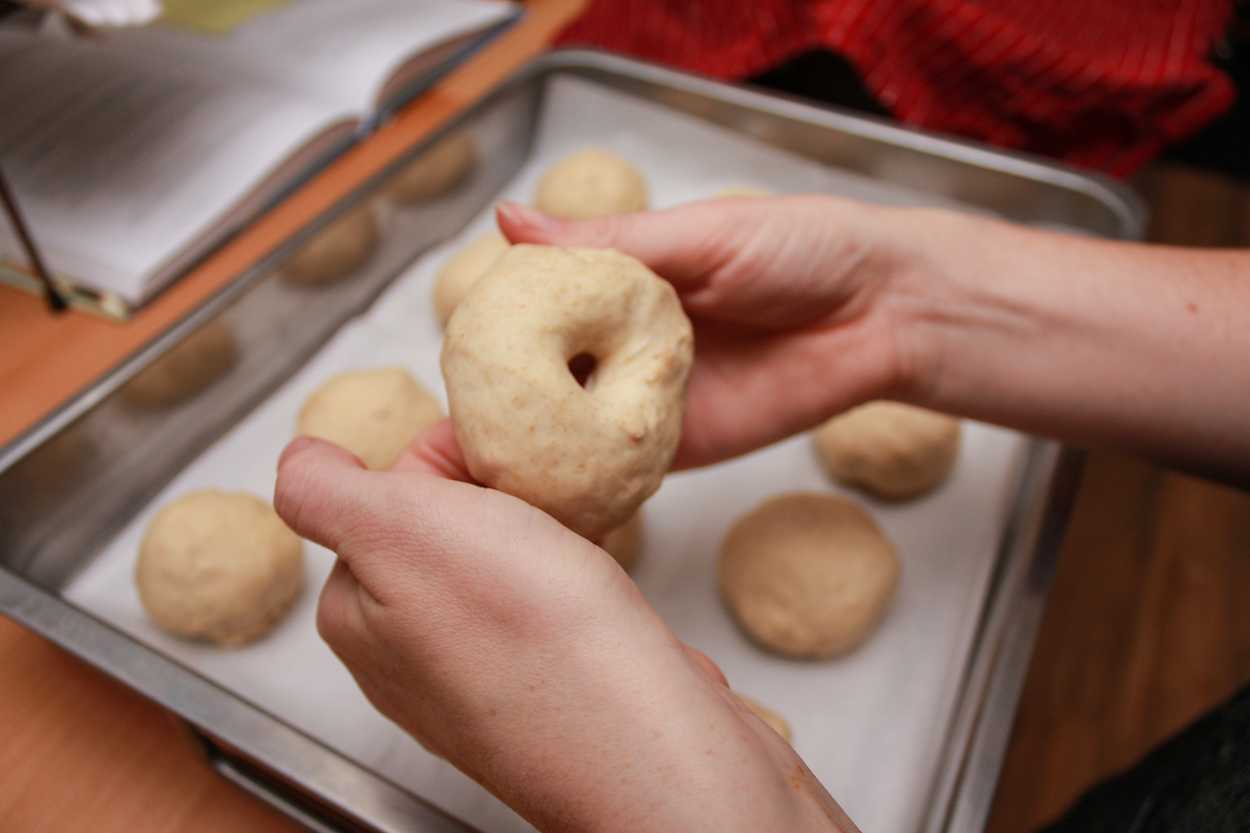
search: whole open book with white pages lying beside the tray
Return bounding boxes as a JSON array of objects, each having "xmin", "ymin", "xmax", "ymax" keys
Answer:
[{"xmin": 0, "ymin": 0, "xmax": 518, "ymax": 306}]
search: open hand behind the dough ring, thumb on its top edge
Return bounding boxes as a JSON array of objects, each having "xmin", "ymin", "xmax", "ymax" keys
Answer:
[{"xmin": 498, "ymin": 196, "xmax": 909, "ymax": 468}]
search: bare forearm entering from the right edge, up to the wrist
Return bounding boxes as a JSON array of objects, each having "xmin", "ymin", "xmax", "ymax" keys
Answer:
[{"xmin": 889, "ymin": 211, "xmax": 1250, "ymax": 480}]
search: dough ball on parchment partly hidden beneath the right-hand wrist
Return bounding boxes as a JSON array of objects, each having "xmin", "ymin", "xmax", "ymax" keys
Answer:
[{"xmin": 813, "ymin": 401, "xmax": 959, "ymax": 500}]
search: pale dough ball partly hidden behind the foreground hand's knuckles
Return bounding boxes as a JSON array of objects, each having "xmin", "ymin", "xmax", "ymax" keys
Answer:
[{"xmin": 299, "ymin": 368, "xmax": 443, "ymax": 469}]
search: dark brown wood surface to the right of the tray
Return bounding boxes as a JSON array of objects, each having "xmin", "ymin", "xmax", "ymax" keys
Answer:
[{"xmin": 989, "ymin": 166, "xmax": 1250, "ymax": 833}]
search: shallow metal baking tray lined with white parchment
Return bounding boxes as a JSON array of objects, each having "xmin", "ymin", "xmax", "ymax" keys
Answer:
[{"xmin": 0, "ymin": 55, "xmax": 1140, "ymax": 833}]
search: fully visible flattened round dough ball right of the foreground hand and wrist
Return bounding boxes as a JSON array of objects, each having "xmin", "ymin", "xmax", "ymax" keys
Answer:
[{"xmin": 720, "ymin": 493, "xmax": 900, "ymax": 658}]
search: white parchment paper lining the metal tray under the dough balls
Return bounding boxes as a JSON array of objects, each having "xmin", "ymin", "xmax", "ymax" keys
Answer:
[{"xmin": 65, "ymin": 80, "xmax": 1026, "ymax": 833}]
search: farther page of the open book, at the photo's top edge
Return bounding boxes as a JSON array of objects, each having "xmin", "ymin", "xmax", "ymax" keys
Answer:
[{"xmin": 113, "ymin": 0, "xmax": 516, "ymax": 115}]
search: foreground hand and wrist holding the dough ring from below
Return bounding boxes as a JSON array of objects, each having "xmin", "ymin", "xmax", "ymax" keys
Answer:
[{"xmin": 274, "ymin": 422, "xmax": 855, "ymax": 833}]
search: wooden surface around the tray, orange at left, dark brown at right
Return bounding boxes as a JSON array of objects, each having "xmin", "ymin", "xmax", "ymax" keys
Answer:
[{"xmin": 0, "ymin": 0, "xmax": 1250, "ymax": 833}]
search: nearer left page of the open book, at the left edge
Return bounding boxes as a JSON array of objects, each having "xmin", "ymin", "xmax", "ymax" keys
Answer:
[{"xmin": 0, "ymin": 30, "xmax": 343, "ymax": 301}]
